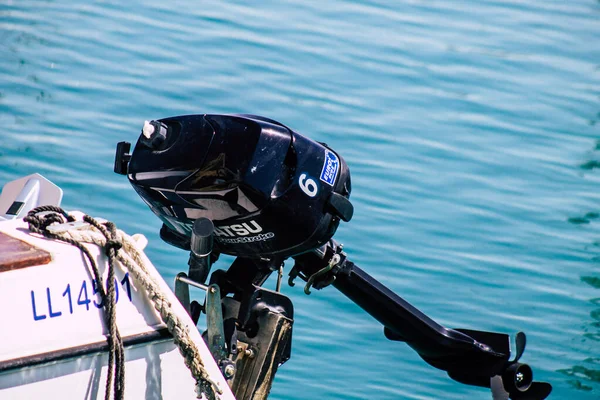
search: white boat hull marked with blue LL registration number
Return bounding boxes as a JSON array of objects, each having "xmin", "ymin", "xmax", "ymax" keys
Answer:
[{"xmin": 0, "ymin": 208, "xmax": 234, "ymax": 399}]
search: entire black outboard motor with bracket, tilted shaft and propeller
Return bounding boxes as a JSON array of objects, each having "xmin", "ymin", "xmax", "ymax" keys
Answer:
[{"xmin": 115, "ymin": 114, "xmax": 552, "ymax": 400}]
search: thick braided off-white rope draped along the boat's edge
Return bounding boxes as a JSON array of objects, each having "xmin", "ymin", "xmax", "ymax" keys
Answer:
[{"xmin": 57, "ymin": 224, "xmax": 223, "ymax": 398}]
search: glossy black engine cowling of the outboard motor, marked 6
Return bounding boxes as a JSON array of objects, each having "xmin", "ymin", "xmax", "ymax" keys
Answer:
[{"xmin": 116, "ymin": 115, "xmax": 353, "ymax": 258}]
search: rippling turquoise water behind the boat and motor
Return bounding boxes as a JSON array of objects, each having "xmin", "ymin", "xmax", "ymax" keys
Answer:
[{"xmin": 0, "ymin": 0, "xmax": 600, "ymax": 400}]
